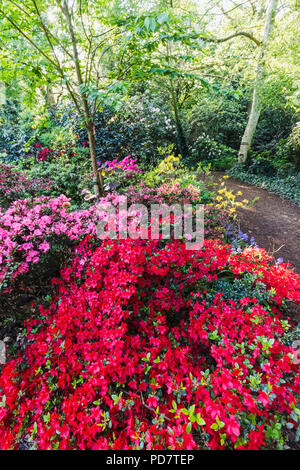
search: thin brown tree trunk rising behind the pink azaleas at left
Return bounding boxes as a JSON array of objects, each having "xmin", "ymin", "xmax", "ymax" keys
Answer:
[{"xmin": 62, "ymin": 0, "xmax": 103, "ymax": 198}]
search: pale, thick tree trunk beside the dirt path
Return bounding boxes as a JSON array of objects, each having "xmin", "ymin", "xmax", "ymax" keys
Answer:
[{"xmin": 238, "ymin": 0, "xmax": 278, "ymax": 163}]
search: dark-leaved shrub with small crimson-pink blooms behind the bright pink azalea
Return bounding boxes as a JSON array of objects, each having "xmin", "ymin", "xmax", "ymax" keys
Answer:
[{"xmin": 0, "ymin": 163, "xmax": 56, "ymax": 205}]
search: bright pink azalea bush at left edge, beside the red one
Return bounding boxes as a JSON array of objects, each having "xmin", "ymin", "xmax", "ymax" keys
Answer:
[{"xmin": 0, "ymin": 195, "xmax": 96, "ymax": 292}]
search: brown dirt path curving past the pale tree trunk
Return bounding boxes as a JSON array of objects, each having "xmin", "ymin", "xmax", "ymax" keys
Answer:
[{"xmin": 213, "ymin": 172, "xmax": 300, "ymax": 273}]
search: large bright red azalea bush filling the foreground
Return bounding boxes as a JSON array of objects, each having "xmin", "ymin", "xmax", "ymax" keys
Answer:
[{"xmin": 0, "ymin": 239, "xmax": 300, "ymax": 450}]
